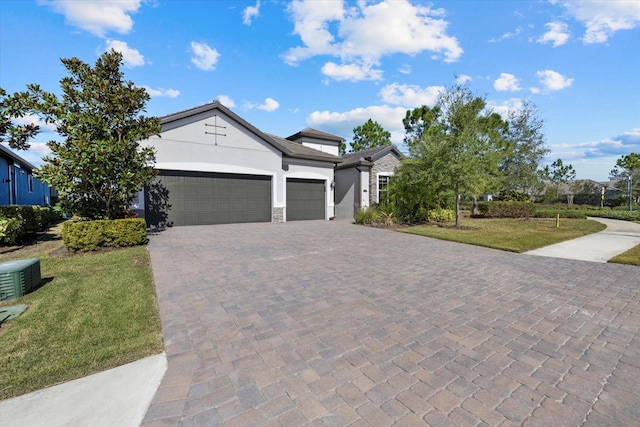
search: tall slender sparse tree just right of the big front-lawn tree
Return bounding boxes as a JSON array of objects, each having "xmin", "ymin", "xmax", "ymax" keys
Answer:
[{"xmin": 500, "ymin": 100, "xmax": 549, "ymax": 194}]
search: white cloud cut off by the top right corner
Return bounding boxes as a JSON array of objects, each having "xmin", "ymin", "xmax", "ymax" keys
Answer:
[{"xmin": 560, "ymin": 0, "xmax": 640, "ymax": 44}]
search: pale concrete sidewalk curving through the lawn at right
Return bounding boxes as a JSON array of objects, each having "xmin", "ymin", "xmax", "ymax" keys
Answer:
[{"xmin": 525, "ymin": 217, "xmax": 640, "ymax": 262}]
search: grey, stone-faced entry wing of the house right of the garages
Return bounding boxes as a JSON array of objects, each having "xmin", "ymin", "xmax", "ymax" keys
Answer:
[{"xmin": 336, "ymin": 145, "xmax": 403, "ymax": 218}]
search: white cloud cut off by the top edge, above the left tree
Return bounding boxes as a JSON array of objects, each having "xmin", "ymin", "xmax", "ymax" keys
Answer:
[{"xmin": 38, "ymin": 0, "xmax": 142, "ymax": 37}]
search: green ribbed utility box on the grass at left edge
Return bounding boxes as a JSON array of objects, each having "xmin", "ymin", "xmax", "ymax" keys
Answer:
[{"xmin": 0, "ymin": 258, "xmax": 41, "ymax": 301}]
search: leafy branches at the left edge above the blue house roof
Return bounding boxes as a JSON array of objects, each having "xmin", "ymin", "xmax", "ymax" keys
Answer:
[{"xmin": 0, "ymin": 88, "xmax": 40, "ymax": 150}]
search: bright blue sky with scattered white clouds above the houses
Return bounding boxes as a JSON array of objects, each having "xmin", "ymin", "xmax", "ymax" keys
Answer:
[{"xmin": 0, "ymin": 0, "xmax": 640, "ymax": 180}]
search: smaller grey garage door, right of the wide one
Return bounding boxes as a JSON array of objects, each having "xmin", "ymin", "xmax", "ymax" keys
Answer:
[{"xmin": 287, "ymin": 178, "xmax": 326, "ymax": 221}]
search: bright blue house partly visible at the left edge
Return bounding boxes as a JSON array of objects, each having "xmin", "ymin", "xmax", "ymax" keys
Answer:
[{"xmin": 0, "ymin": 145, "xmax": 51, "ymax": 206}]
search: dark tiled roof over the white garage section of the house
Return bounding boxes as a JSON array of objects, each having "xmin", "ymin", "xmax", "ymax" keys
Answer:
[{"xmin": 160, "ymin": 101, "xmax": 342, "ymax": 163}]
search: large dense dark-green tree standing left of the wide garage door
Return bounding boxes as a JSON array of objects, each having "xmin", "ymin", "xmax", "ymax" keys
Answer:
[{"xmin": 30, "ymin": 50, "xmax": 161, "ymax": 219}]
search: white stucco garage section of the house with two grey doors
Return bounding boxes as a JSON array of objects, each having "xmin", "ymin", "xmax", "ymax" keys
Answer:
[{"xmin": 138, "ymin": 101, "xmax": 343, "ymax": 225}]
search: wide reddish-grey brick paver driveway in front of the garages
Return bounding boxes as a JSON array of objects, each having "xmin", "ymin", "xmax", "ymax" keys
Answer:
[{"xmin": 143, "ymin": 221, "xmax": 640, "ymax": 427}]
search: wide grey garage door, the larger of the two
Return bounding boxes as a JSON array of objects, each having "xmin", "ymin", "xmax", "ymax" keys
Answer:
[{"xmin": 156, "ymin": 171, "xmax": 271, "ymax": 225}]
